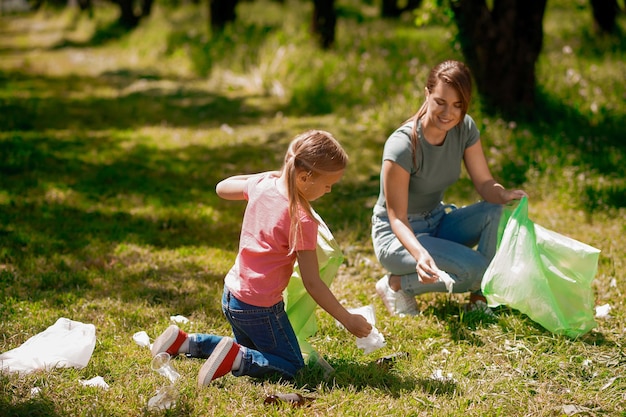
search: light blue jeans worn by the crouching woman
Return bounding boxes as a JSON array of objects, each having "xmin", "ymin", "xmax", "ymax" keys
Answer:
[{"xmin": 372, "ymin": 202, "xmax": 502, "ymax": 295}]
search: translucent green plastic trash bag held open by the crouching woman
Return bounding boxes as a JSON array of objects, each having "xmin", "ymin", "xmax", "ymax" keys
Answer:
[{"xmin": 482, "ymin": 197, "xmax": 600, "ymax": 337}]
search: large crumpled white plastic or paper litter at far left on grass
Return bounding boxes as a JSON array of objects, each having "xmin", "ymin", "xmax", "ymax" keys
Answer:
[{"xmin": 0, "ymin": 317, "xmax": 96, "ymax": 373}]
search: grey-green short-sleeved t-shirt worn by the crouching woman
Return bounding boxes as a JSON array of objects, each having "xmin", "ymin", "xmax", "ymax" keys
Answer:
[{"xmin": 374, "ymin": 115, "xmax": 480, "ymax": 216}]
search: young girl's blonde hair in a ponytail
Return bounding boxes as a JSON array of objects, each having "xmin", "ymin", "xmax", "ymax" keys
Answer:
[{"xmin": 282, "ymin": 130, "xmax": 348, "ymax": 252}]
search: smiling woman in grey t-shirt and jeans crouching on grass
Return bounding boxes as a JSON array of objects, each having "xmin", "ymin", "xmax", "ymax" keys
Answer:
[{"xmin": 372, "ymin": 61, "xmax": 526, "ymax": 315}]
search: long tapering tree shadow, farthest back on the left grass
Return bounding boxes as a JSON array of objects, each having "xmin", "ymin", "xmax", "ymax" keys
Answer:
[{"xmin": 0, "ymin": 70, "xmax": 279, "ymax": 132}]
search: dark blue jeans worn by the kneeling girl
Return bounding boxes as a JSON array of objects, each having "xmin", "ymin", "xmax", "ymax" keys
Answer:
[{"xmin": 189, "ymin": 287, "xmax": 304, "ymax": 379}]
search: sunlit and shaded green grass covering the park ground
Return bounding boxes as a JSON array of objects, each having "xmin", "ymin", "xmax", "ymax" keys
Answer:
[{"xmin": 0, "ymin": 0, "xmax": 626, "ymax": 416}]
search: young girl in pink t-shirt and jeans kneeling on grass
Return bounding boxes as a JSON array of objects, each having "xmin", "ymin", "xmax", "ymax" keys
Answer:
[{"xmin": 152, "ymin": 130, "xmax": 372, "ymax": 387}]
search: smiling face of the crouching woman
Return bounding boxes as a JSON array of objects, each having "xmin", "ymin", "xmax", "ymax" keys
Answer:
[{"xmin": 423, "ymin": 81, "xmax": 463, "ymax": 136}]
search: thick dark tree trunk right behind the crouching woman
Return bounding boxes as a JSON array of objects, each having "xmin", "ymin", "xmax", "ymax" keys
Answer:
[{"xmin": 452, "ymin": 0, "xmax": 547, "ymax": 112}]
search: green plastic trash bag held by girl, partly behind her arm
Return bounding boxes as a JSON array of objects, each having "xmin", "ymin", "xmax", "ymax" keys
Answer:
[{"xmin": 283, "ymin": 212, "xmax": 344, "ymax": 362}]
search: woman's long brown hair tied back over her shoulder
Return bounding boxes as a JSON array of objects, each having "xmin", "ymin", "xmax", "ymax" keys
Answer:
[{"xmin": 405, "ymin": 60, "xmax": 472, "ymax": 167}]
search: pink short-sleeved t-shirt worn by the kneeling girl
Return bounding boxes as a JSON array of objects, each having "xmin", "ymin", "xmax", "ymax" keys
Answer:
[{"xmin": 225, "ymin": 175, "xmax": 317, "ymax": 307}]
